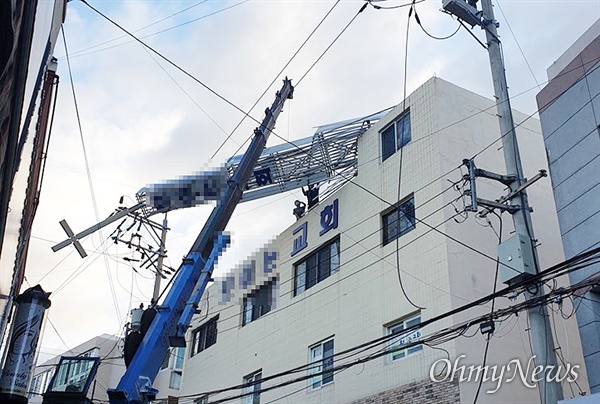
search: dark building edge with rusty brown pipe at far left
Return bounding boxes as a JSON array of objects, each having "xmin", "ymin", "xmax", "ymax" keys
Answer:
[{"xmin": 0, "ymin": 0, "xmax": 67, "ymax": 351}]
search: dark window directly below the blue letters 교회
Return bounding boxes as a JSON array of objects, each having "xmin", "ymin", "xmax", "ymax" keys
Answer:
[{"xmin": 294, "ymin": 239, "xmax": 340, "ymax": 296}]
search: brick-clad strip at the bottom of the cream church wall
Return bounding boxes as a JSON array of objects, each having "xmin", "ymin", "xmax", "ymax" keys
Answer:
[{"xmin": 351, "ymin": 379, "xmax": 460, "ymax": 404}]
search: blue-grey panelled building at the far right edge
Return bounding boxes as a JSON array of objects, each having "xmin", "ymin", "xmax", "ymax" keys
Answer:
[{"xmin": 537, "ymin": 20, "xmax": 600, "ymax": 394}]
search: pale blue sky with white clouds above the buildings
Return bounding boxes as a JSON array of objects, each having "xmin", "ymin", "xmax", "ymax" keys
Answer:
[{"xmin": 25, "ymin": 0, "xmax": 600, "ymax": 360}]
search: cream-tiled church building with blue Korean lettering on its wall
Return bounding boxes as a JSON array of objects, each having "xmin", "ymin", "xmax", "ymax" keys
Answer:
[{"xmin": 180, "ymin": 78, "xmax": 588, "ymax": 404}]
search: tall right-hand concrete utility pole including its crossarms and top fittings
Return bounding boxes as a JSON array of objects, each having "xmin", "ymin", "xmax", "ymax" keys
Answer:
[{"xmin": 442, "ymin": 0, "xmax": 563, "ymax": 404}]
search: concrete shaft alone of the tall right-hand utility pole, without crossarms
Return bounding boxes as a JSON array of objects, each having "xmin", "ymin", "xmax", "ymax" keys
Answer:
[{"xmin": 481, "ymin": 0, "xmax": 563, "ymax": 404}]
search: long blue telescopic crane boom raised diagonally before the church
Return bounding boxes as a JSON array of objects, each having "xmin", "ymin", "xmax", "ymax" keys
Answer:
[{"xmin": 108, "ymin": 78, "xmax": 294, "ymax": 404}]
